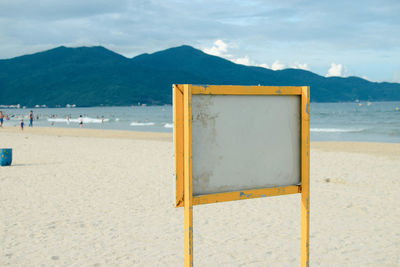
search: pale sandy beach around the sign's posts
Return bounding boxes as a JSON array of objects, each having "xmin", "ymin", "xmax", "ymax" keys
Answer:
[{"xmin": 0, "ymin": 127, "xmax": 400, "ymax": 267}]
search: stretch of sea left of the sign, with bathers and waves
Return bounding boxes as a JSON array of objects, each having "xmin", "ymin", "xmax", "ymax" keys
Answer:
[{"xmin": 0, "ymin": 106, "xmax": 173, "ymax": 132}]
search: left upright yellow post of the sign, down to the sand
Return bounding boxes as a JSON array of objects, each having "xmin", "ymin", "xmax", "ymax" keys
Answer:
[{"xmin": 183, "ymin": 84, "xmax": 193, "ymax": 267}]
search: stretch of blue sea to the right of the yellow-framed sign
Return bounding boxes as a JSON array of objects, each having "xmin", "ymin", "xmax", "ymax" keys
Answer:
[{"xmin": 310, "ymin": 102, "xmax": 400, "ymax": 143}]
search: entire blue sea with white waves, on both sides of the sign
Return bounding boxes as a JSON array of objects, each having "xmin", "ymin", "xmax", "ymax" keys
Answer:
[{"xmin": 2, "ymin": 102, "xmax": 400, "ymax": 143}]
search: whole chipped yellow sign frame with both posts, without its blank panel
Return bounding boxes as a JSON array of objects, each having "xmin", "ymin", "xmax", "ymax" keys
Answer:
[{"xmin": 174, "ymin": 84, "xmax": 310, "ymax": 267}]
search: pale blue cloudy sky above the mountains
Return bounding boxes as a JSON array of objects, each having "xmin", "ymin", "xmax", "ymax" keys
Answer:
[{"xmin": 0, "ymin": 0, "xmax": 400, "ymax": 82}]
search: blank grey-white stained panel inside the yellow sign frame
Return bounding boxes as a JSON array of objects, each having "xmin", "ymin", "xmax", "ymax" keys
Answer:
[{"xmin": 192, "ymin": 95, "xmax": 301, "ymax": 195}]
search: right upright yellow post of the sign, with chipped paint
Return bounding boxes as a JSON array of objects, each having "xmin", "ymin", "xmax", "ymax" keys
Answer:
[{"xmin": 301, "ymin": 86, "xmax": 310, "ymax": 267}]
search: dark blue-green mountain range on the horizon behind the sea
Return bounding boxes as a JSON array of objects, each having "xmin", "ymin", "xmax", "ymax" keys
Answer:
[{"xmin": 0, "ymin": 45, "xmax": 400, "ymax": 107}]
